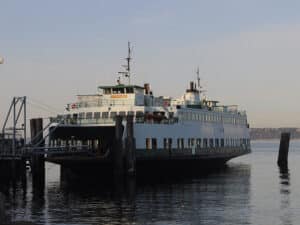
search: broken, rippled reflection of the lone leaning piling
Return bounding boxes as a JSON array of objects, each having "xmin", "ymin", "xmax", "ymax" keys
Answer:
[{"xmin": 279, "ymin": 166, "xmax": 293, "ymax": 225}]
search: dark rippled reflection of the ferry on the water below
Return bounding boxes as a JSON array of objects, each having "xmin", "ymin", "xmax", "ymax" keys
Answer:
[{"xmin": 2, "ymin": 164, "xmax": 251, "ymax": 224}]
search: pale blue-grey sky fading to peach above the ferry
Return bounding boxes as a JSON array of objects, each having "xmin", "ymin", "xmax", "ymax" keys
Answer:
[{"xmin": 0, "ymin": 0, "xmax": 300, "ymax": 127}]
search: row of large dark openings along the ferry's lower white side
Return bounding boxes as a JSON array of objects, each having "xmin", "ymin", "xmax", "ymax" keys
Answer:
[{"xmin": 146, "ymin": 138, "xmax": 250, "ymax": 149}]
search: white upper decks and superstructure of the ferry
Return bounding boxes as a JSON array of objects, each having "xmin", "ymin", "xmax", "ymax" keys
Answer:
[{"xmin": 49, "ymin": 42, "xmax": 250, "ymax": 155}]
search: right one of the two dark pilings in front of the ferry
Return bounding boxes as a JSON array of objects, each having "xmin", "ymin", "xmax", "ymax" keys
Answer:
[{"xmin": 125, "ymin": 115, "xmax": 136, "ymax": 175}]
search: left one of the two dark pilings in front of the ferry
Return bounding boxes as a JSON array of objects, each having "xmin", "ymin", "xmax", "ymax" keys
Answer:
[{"xmin": 112, "ymin": 116, "xmax": 124, "ymax": 179}]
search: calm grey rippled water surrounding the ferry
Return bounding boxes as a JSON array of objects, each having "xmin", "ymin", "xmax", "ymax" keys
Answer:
[{"xmin": 6, "ymin": 140, "xmax": 300, "ymax": 225}]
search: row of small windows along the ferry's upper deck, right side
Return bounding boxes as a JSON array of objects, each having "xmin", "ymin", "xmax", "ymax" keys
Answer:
[{"xmin": 179, "ymin": 112, "xmax": 247, "ymax": 124}]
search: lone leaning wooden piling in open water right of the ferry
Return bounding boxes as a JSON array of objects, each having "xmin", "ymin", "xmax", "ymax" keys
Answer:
[{"xmin": 277, "ymin": 133, "xmax": 291, "ymax": 167}]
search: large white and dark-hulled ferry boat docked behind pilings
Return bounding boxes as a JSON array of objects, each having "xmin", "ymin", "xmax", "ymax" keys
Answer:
[{"xmin": 48, "ymin": 44, "xmax": 251, "ymax": 176}]
